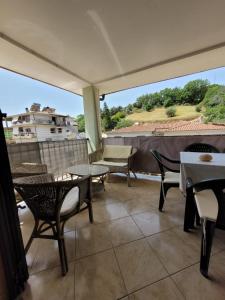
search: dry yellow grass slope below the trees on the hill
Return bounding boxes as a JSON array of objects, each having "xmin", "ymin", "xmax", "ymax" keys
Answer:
[{"xmin": 127, "ymin": 105, "xmax": 201, "ymax": 122}]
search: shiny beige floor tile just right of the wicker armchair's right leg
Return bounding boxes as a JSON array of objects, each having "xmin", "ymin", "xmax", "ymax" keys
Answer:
[{"xmin": 93, "ymin": 201, "xmax": 128, "ymax": 223}]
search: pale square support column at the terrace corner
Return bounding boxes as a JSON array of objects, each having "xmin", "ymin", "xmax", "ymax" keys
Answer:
[{"xmin": 83, "ymin": 86, "xmax": 102, "ymax": 152}]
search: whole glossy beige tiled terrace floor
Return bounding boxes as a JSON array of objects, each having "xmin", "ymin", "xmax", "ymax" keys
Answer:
[{"xmin": 20, "ymin": 176, "xmax": 225, "ymax": 300}]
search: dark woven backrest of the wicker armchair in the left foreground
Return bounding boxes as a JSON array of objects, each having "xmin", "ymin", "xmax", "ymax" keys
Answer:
[{"xmin": 14, "ymin": 174, "xmax": 91, "ymax": 220}]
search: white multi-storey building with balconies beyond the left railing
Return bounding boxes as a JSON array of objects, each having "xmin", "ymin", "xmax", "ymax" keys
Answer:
[{"xmin": 8, "ymin": 103, "xmax": 78, "ymax": 143}]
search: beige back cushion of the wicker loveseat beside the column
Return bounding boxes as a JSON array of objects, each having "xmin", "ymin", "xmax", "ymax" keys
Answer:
[{"xmin": 103, "ymin": 145, "xmax": 132, "ymax": 160}]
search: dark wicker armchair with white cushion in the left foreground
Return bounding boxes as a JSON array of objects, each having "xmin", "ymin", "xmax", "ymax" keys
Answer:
[{"xmin": 14, "ymin": 174, "xmax": 93, "ymax": 275}]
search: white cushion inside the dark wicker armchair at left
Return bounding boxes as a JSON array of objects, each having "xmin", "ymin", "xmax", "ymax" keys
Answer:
[{"xmin": 60, "ymin": 186, "xmax": 79, "ymax": 216}]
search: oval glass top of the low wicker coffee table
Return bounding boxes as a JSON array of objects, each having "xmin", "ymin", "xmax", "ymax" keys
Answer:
[{"xmin": 66, "ymin": 164, "xmax": 109, "ymax": 177}]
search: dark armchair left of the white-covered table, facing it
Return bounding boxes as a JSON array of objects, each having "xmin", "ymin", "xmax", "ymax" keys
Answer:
[{"xmin": 150, "ymin": 149, "xmax": 180, "ymax": 211}]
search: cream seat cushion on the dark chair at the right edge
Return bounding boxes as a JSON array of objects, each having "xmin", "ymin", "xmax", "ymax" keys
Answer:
[{"xmin": 195, "ymin": 190, "xmax": 219, "ymax": 221}]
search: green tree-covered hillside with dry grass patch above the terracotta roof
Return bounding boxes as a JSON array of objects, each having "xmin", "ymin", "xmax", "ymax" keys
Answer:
[{"xmin": 75, "ymin": 79, "xmax": 225, "ymax": 131}]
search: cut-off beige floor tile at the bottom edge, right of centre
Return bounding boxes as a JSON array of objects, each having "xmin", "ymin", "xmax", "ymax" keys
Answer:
[{"xmin": 129, "ymin": 278, "xmax": 184, "ymax": 300}]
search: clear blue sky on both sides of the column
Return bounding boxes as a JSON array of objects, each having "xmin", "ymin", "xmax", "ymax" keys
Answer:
[{"xmin": 0, "ymin": 67, "xmax": 225, "ymax": 116}]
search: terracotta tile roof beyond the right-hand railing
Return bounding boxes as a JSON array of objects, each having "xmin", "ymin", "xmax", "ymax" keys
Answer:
[{"xmin": 114, "ymin": 118, "xmax": 225, "ymax": 132}]
